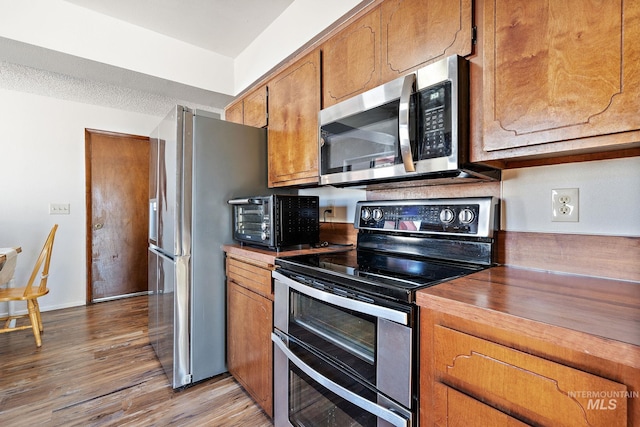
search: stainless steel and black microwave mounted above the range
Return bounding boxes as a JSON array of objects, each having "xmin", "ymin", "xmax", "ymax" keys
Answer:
[{"xmin": 319, "ymin": 55, "xmax": 500, "ymax": 186}]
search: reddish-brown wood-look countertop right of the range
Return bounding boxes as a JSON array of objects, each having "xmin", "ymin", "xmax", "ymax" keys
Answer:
[{"xmin": 417, "ymin": 267, "xmax": 640, "ymax": 352}]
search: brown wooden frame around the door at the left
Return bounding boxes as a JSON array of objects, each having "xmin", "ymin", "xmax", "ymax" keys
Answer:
[{"xmin": 84, "ymin": 128, "xmax": 149, "ymax": 305}]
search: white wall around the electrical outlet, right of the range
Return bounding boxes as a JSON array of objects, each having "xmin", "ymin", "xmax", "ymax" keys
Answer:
[{"xmin": 502, "ymin": 157, "xmax": 640, "ymax": 236}]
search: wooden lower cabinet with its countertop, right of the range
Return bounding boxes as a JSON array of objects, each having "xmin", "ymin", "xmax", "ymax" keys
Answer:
[{"xmin": 417, "ymin": 267, "xmax": 640, "ymax": 427}]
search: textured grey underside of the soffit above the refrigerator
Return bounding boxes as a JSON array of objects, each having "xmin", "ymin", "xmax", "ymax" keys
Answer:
[{"xmin": 0, "ymin": 37, "xmax": 233, "ymax": 116}]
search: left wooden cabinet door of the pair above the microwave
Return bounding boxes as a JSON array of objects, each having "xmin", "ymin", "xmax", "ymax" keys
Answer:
[{"xmin": 322, "ymin": 7, "xmax": 380, "ymax": 107}]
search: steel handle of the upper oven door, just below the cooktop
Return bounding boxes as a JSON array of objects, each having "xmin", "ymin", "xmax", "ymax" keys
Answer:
[{"xmin": 272, "ymin": 271, "xmax": 409, "ymax": 325}]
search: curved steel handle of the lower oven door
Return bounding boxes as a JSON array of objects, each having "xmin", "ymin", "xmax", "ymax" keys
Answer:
[{"xmin": 271, "ymin": 332, "xmax": 411, "ymax": 427}]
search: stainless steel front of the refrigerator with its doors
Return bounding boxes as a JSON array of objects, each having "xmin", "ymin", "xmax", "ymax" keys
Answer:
[{"xmin": 149, "ymin": 106, "xmax": 193, "ymax": 388}]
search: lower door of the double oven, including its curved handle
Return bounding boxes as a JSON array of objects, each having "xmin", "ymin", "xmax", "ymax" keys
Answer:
[{"xmin": 272, "ymin": 332, "xmax": 412, "ymax": 427}]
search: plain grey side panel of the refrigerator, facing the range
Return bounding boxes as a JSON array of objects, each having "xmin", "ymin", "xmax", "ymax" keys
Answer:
[{"xmin": 191, "ymin": 111, "xmax": 267, "ymax": 382}]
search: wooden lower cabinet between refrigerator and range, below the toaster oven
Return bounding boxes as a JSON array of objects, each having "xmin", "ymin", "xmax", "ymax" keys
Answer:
[{"xmin": 226, "ymin": 254, "xmax": 273, "ymax": 417}]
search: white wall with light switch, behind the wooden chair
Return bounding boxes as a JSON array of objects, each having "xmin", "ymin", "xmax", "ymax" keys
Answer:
[{"xmin": 0, "ymin": 89, "xmax": 160, "ymax": 313}]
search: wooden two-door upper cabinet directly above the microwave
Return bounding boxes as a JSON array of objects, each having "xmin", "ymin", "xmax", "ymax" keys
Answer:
[{"xmin": 322, "ymin": 0, "xmax": 473, "ymax": 107}]
